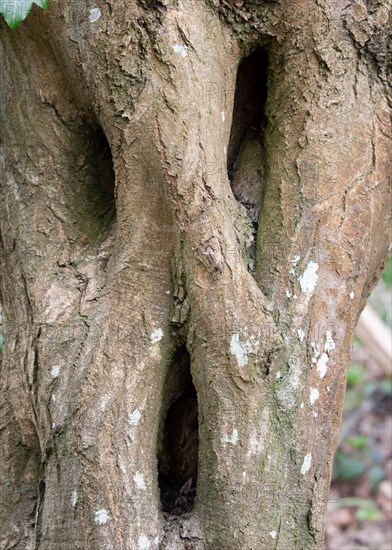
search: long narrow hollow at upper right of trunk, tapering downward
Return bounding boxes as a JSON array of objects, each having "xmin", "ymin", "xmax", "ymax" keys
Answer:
[{"xmin": 227, "ymin": 48, "xmax": 268, "ymax": 272}]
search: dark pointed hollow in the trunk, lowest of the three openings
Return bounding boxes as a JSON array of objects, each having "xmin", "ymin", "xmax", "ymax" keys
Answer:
[{"xmin": 158, "ymin": 347, "xmax": 199, "ymax": 515}]
